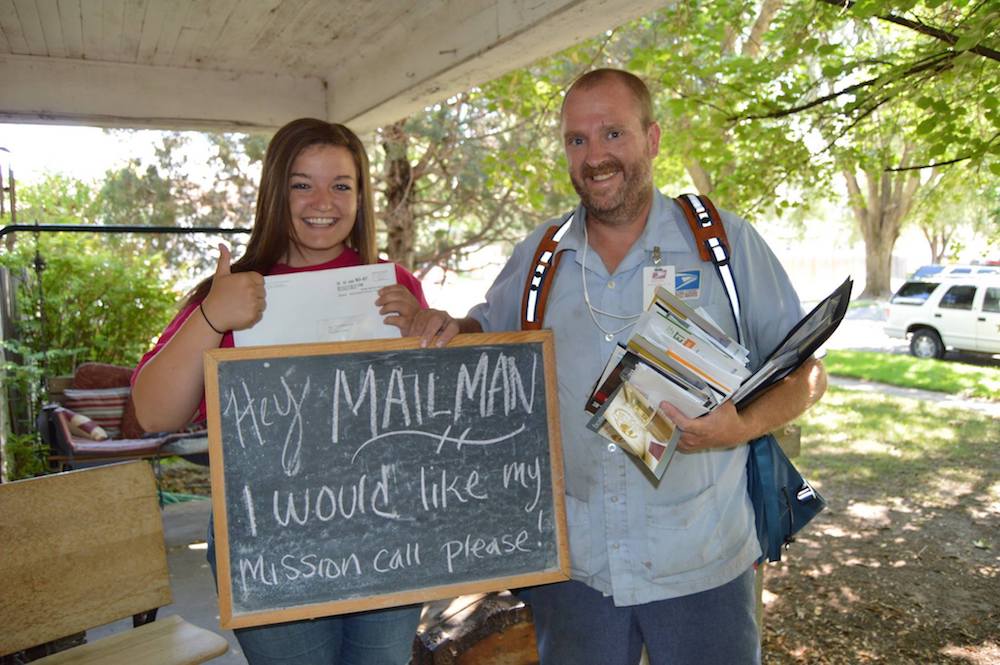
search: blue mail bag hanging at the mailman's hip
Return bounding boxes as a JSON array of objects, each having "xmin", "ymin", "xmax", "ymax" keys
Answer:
[{"xmin": 747, "ymin": 434, "xmax": 826, "ymax": 563}]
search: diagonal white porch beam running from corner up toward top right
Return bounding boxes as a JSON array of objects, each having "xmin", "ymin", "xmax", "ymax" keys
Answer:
[{"xmin": 327, "ymin": 0, "xmax": 664, "ymax": 132}]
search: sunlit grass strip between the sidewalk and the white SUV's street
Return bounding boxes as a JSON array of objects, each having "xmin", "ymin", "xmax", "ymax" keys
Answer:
[{"xmin": 823, "ymin": 350, "xmax": 1000, "ymax": 400}]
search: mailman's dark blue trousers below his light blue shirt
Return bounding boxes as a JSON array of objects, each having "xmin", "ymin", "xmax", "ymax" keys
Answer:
[{"xmin": 519, "ymin": 569, "xmax": 760, "ymax": 665}]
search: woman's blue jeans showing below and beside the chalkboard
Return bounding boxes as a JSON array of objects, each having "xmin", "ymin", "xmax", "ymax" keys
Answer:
[{"xmin": 207, "ymin": 521, "xmax": 421, "ymax": 665}]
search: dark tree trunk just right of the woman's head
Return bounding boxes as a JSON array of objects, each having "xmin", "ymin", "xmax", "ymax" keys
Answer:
[{"xmin": 382, "ymin": 120, "xmax": 416, "ymax": 270}]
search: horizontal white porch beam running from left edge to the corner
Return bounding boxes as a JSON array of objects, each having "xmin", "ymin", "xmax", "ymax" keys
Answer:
[{"xmin": 0, "ymin": 55, "xmax": 327, "ymax": 131}]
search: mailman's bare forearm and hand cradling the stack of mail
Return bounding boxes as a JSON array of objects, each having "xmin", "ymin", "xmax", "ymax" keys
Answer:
[{"xmin": 660, "ymin": 358, "xmax": 826, "ymax": 453}]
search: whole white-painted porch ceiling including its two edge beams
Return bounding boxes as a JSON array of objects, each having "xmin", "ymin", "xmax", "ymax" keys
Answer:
[{"xmin": 0, "ymin": 0, "xmax": 664, "ymax": 132}]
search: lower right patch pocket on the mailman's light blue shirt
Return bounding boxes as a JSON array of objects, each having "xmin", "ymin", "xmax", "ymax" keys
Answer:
[{"xmin": 646, "ymin": 485, "xmax": 721, "ymax": 579}]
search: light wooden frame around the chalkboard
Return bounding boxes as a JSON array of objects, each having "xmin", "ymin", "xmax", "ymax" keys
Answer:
[{"xmin": 204, "ymin": 330, "xmax": 570, "ymax": 628}]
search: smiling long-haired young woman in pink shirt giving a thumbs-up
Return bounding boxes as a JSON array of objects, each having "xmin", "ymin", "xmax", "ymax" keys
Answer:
[{"xmin": 132, "ymin": 118, "xmax": 427, "ymax": 665}]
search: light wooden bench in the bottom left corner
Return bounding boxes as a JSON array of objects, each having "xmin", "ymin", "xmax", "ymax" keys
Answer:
[{"xmin": 0, "ymin": 462, "xmax": 229, "ymax": 665}]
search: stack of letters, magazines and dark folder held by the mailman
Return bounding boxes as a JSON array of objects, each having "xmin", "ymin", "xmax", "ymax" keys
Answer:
[{"xmin": 586, "ymin": 278, "xmax": 853, "ymax": 478}]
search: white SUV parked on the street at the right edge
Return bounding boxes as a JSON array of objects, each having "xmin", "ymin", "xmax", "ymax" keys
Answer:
[{"xmin": 885, "ymin": 275, "xmax": 1000, "ymax": 358}]
